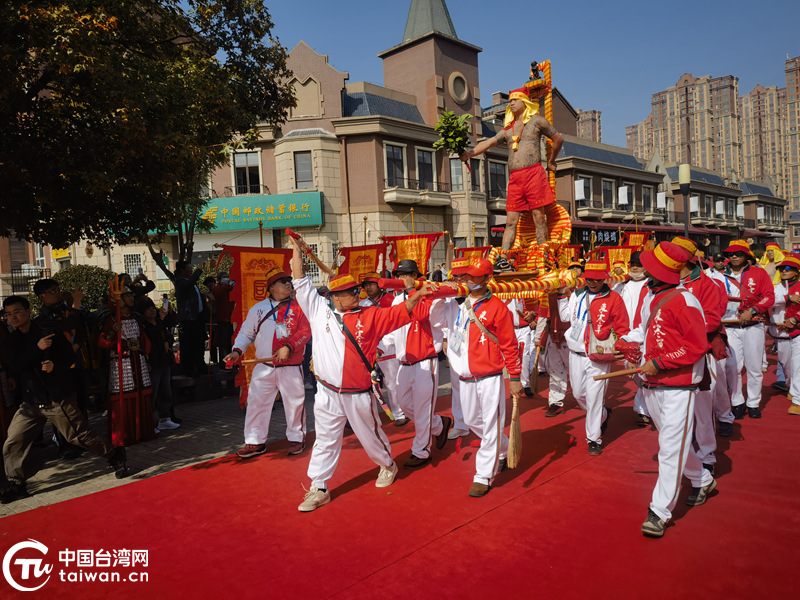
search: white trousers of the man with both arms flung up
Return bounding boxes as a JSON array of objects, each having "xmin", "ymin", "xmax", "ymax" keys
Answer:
[{"xmin": 308, "ymin": 383, "xmax": 393, "ymax": 489}]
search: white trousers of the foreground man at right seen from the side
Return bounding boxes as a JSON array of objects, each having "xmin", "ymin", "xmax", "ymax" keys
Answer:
[{"xmin": 643, "ymin": 390, "xmax": 712, "ymax": 521}]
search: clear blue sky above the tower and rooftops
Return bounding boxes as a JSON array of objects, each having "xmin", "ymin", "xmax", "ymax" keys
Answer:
[{"xmin": 266, "ymin": 0, "xmax": 800, "ymax": 146}]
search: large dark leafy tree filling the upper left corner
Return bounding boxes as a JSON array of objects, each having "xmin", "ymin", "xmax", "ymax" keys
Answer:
[{"xmin": 0, "ymin": 0, "xmax": 295, "ymax": 276}]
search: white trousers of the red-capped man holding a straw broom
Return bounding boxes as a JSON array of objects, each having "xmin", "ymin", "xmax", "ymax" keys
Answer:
[{"xmin": 461, "ymin": 375, "xmax": 508, "ymax": 485}]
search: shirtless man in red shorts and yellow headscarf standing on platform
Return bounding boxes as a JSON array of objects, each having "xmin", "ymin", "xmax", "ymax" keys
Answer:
[{"xmin": 461, "ymin": 88, "xmax": 564, "ymax": 264}]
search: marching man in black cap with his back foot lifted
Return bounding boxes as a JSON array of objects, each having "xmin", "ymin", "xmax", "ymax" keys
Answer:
[{"xmin": 390, "ymin": 259, "xmax": 453, "ymax": 469}]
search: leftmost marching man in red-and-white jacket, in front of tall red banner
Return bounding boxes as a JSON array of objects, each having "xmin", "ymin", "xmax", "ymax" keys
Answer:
[{"xmin": 224, "ymin": 267, "xmax": 311, "ymax": 458}]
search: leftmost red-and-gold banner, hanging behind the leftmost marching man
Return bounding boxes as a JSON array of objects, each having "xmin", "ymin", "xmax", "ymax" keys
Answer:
[{"xmin": 222, "ymin": 246, "xmax": 292, "ymax": 407}]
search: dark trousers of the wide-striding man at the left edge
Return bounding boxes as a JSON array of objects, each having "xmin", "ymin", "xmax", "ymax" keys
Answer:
[{"xmin": 3, "ymin": 395, "xmax": 113, "ymax": 484}]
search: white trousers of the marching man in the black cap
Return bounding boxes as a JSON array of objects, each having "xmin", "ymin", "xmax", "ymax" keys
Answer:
[{"xmin": 397, "ymin": 356, "xmax": 442, "ymax": 458}]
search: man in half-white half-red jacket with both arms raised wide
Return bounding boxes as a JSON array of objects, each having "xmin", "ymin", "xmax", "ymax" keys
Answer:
[{"xmin": 292, "ymin": 238, "xmax": 430, "ymax": 512}]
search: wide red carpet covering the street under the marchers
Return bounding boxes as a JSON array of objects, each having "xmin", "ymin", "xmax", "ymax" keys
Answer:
[{"xmin": 0, "ymin": 368, "xmax": 800, "ymax": 600}]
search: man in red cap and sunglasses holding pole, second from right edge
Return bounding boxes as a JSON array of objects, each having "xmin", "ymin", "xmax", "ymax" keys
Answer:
[{"xmin": 723, "ymin": 240, "xmax": 775, "ymax": 419}]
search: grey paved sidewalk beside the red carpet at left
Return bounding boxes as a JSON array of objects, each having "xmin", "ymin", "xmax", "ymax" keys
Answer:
[{"xmin": 0, "ymin": 362, "xmax": 450, "ymax": 518}]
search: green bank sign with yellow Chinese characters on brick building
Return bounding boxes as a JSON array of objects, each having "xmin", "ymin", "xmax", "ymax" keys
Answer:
[{"xmin": 201, "ymin": 192, "xmax": 324, "ymax": 231}]
